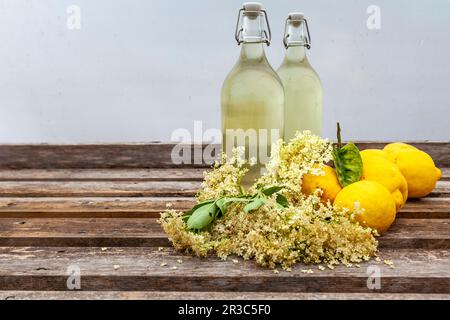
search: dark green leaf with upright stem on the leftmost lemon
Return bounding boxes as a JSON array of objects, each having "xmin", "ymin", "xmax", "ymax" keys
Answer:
[{"xmin": 333, "ymin": 123, "xmax": 363, "ymax": 187}]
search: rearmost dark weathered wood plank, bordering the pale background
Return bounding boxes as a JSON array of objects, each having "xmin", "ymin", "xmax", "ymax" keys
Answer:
[{"xmin": 0, "ymin": 142, "xmax": 450, "ymax": 169}]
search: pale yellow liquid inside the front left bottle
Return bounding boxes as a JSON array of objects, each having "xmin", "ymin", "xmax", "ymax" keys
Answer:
[{"xmin": 222, "ymin": 43, "xmax": 284, "ymax": 187}]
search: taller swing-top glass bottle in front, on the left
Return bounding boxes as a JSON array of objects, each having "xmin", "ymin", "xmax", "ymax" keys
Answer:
[{"xmin": 221, "ymin": 2, "xmax": 284, "ymax": 187}]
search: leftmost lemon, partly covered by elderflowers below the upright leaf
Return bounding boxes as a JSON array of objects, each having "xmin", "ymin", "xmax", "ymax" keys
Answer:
[{"xmin": 302, "ymin": 166, "xmax": 342, "ymax": 203}]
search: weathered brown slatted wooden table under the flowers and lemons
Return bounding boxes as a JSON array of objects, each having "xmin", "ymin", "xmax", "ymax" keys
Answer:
[{"xmin": 0, "ymin": 143, "xmax": 450, "ymax": 299}]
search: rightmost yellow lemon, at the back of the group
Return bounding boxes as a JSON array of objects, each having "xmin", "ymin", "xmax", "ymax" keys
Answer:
[{"xmin": 384, "ymin": 143, "xmax": 441, "ymax": 198}]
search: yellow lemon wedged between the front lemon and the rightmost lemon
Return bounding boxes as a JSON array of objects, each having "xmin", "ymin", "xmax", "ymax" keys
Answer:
[{"xmin": 361, "ymin": 150, "xmax": 408, "ymax": 211}]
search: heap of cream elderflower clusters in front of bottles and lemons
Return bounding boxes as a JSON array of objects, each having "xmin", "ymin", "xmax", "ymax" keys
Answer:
[{"xmin": 160, "ymin": 132, "xmax": 378, "ymax": 269}]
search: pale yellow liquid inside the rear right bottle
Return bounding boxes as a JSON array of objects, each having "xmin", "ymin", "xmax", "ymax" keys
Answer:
[{"xmin": 278, "ymin": 46, "xmax": 323, "ymax": 141}]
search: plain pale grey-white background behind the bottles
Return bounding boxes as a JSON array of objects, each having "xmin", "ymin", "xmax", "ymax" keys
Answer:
[{"xmin": 0, "ymin": 0, "xmax": 450, "ymax": 143}]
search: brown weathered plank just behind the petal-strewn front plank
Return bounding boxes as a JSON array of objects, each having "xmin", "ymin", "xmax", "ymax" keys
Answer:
[{"xmin": 0, "ymin": 218, "xmax": 450, "ymax": 249}]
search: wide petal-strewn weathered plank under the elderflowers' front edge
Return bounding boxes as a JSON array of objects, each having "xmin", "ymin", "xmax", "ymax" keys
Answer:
[{"xmin": 0, "ymin": 248, "xmax": 450, "ymax": 294}]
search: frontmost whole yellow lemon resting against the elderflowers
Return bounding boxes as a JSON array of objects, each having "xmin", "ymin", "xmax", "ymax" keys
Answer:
[{"xmin": 334, "ymin": 180, "xmax": 397, "ymax": 234}]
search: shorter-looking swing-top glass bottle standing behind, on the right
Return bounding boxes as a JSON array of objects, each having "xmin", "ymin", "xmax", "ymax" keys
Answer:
[{"xmin": 278, "ymin": 12, "xmax": 322, "ymax": 141}]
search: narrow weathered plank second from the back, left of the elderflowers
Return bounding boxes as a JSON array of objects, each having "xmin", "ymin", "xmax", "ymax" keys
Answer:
[{"xmin": 0, "ymin": 168, "xmax": 205, "ymax": 181}]
